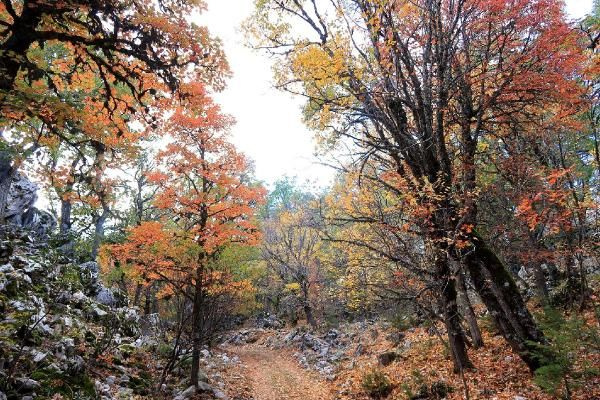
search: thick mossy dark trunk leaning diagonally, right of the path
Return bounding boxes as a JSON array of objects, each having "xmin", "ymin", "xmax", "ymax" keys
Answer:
[{"xmin": 457, "ymin": 235, "xmax": 545, "ymax": 371}]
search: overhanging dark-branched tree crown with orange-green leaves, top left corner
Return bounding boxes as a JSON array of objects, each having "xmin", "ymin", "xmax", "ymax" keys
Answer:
[{"xmin": 0, "ymin": 0, "xmax": 227, "ymax": 221}]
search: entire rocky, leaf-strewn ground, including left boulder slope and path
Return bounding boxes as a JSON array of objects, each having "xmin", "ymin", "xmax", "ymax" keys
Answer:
[{"xmin": 0, "ymin": 225, "xmax": 600, "ymax": 400}]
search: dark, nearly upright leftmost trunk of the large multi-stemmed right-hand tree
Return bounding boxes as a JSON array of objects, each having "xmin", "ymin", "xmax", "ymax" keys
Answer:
[{"xmin": 435, "ymin": 251, "xmax": 473, "ymax": 372}]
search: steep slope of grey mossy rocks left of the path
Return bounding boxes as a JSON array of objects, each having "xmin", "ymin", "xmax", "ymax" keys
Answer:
[{"xmin": 0, "ymin": 228, "xmax": 235, "ymax": 400}]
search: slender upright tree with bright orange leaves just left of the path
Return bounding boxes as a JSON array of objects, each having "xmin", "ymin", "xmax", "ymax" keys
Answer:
[{"xmin": 149, "ymin": 83, "xmax": 264, "ymax": 384}]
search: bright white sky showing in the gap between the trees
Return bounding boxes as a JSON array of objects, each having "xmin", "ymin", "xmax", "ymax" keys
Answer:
[{"xmin": 202, "ymin": 0, "xmax": 593, "ymax": 190}]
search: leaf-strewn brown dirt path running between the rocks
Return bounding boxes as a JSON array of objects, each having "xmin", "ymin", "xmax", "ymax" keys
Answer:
[{"xmin": 228, "ymin": 346, "xmax": 334, "ymax": 400}]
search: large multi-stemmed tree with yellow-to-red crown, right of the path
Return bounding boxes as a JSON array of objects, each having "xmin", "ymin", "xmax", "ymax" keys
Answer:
[{"xmin": 251, "ymin": 0, "xmax": 581, "ymax": 369}]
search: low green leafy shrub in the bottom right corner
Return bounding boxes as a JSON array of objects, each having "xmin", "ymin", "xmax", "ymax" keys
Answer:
[{"xmin": 529, "ymin": 307, "xmax": 600, "ymax": 398}]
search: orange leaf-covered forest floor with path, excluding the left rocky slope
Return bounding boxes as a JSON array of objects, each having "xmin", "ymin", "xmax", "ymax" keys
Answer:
[{"xmin": 214, "ymin": 318, "xmax": 600, "ymax": 400}]
